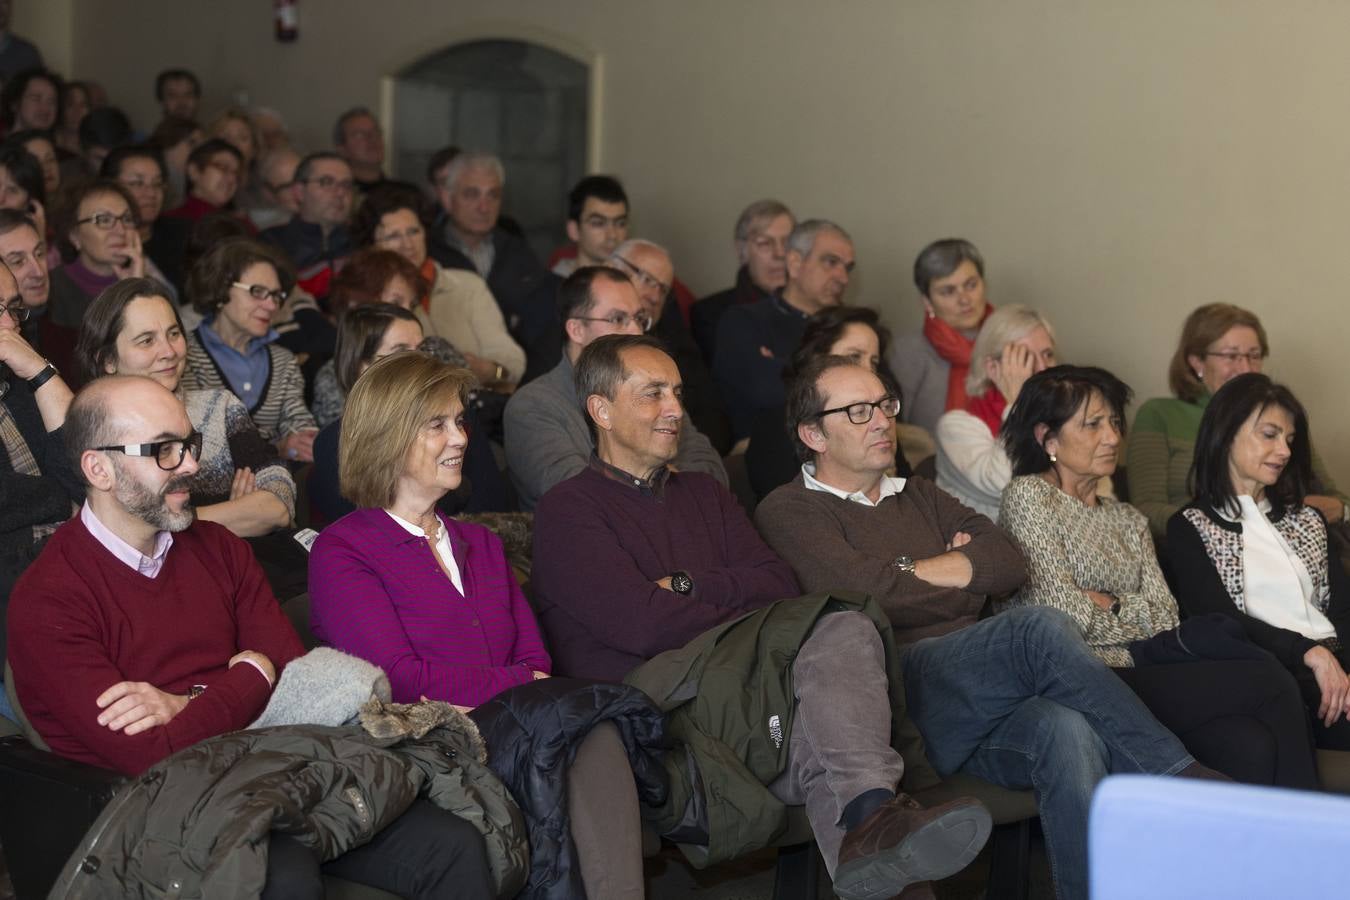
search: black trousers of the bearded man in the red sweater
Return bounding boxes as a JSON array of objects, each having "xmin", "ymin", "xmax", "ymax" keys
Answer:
[{"xmin": 262, "ymin": 799, "xmax": 493, "ymax": 900}]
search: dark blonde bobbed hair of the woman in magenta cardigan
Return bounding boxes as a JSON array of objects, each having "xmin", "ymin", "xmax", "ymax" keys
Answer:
[{"xmin": 338, "ymin": 349, "xmax": 475, "ymax": 509}]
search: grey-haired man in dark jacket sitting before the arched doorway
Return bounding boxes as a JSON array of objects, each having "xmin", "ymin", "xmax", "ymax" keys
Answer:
[{"xmin": 428, "ymin": 152, "xmax": 563, "ymax": 385}]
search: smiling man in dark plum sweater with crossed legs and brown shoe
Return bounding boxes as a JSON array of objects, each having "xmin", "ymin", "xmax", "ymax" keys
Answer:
[{"xmin": 533, "ymin": 335, "xmax": 990, "ymax": 900}]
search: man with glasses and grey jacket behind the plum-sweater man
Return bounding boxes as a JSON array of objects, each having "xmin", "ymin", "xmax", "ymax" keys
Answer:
[{"xmin": 504, "ymin": 266, "xmax": 726, "ymax": 510}]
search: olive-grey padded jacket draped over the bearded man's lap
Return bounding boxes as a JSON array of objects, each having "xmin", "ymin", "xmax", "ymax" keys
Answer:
[{"xmin": 49, "ymin": 716, "xmax": 528, "ymax": 900}]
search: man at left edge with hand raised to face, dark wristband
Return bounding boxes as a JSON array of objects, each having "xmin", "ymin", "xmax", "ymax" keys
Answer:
[{"xmin": 0, "ymin": 259, "xmax": 84, "ymax": 718}]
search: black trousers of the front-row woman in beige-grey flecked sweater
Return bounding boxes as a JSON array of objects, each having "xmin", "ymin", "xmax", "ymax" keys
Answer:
[{"xmin": 1115, "ymin": 660, "xmax": 1319, "ymax": 791}]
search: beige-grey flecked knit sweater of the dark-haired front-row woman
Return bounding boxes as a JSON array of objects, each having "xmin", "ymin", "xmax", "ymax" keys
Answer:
[{"xmin": 999, "ymin": 475, "xmax": 1177, "ymax": 667}]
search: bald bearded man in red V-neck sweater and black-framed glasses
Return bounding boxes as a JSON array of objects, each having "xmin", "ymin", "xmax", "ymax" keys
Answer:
[{"xmin": 9, "ymin": 376, "xmax": 491, "ymax": 897}]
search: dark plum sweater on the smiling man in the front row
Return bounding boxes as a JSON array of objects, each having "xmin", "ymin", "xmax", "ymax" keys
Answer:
[{"xmin": 531, "ymin": 466, "xmax": 801, "ymax": 681}]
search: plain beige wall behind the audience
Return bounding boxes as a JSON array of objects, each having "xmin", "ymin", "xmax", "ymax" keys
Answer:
[{"xmin": 68, "ymin": 0, "xmax": 1350, "ymax": 486}]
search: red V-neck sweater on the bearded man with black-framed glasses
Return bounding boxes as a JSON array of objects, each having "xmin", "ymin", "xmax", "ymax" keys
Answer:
[{"xmin": 9, "ymin": 515, "xmax": 304, "ymax": 775}]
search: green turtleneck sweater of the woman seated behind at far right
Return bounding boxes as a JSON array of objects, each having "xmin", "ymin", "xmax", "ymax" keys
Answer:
[{"xmin": 1126, "ymin": 394, "xmax": 1350, "ymax": 540}]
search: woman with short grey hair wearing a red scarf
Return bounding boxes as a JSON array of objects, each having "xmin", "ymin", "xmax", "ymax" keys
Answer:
[{"xmin": 890, "ymin": 237, "xmax": 994, "ymax": 433}]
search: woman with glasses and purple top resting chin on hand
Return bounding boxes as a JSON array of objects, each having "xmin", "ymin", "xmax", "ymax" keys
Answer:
[{"xmin": 42, "ymin": 179, "xmax": 153, "ymax": 389}]
